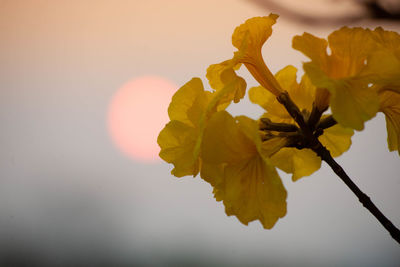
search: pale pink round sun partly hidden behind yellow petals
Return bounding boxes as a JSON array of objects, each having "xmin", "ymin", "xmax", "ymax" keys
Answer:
[{"xmin": 107, "ymin": 76, "xmax": 177, "ymax": 162}]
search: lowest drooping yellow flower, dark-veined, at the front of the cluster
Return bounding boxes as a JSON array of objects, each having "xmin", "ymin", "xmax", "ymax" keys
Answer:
[{"xmin": 201, "ymin": 111, "xmax": 287, "ymax": 229}]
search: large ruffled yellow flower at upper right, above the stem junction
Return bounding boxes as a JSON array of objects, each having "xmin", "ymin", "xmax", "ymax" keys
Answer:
[{"xmin": 293, "ymin": 27, "xmax": 379, "ymax": 130}]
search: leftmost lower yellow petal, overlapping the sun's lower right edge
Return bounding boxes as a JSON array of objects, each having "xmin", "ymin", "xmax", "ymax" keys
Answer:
[{"xmin": 157, "ymin": 120, "xmax": 199, "ymax": 177}]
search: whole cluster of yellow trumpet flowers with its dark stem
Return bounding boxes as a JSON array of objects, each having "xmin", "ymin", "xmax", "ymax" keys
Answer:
[{"xmin": 158, "ymin": 14, "xmax": 400, "ymax": 243}]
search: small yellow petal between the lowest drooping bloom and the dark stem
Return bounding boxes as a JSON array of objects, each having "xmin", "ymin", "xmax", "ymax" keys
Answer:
[{"xmin": 271, "ymin": 147, "xmax": 321, "ymax": 181}]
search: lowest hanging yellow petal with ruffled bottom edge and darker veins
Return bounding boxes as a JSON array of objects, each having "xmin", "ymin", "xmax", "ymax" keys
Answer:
[{"xmin": 219, "ymin": 156, "xmax": 287, "ymax": 229}]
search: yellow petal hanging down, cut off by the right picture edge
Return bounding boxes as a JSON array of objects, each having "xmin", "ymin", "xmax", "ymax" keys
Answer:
[{"xmin": 379, "ymin": 90, "xmax": 400, "ymax": 154}]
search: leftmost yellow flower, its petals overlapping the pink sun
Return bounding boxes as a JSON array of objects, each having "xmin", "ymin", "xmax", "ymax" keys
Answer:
[{"xmin": 157, "ymin": 72, "xmax": 246, "ymax": 177}]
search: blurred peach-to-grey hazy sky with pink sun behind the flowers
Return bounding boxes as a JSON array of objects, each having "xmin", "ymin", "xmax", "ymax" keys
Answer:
[{"xmin": 0, "ymin": 0, "xmax": 400, "ymax": 266}]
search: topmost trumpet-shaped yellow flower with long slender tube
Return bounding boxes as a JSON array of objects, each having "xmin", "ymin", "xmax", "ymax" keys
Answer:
[{"xmin": 207, "ymin": 14, "xmax": 282, "ymax": 97}]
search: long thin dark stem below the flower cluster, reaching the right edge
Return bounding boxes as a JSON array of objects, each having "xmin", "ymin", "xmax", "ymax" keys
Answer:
[{"xmin": 313, "ymin": 141, "xmax": 400, "ymax": 244}]
